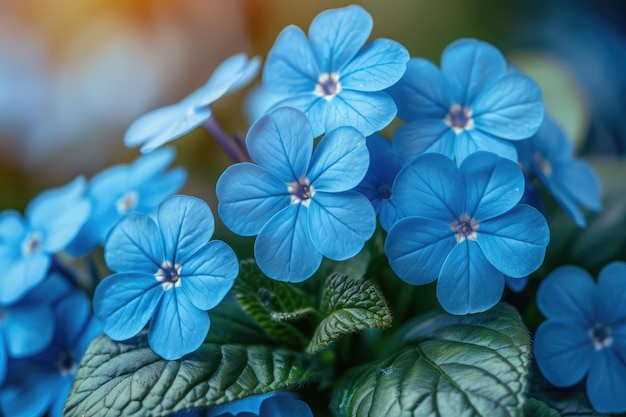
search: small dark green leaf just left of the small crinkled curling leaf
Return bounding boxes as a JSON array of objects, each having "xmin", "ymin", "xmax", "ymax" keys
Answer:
[{"xmin": 232, "ymin": 261, "xmax": 315, "ymax": 349}]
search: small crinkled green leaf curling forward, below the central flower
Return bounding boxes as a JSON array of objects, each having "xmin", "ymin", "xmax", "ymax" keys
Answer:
[{"xmin": 306, "ymin": 274, "xmax": 391, "ymax": 353}]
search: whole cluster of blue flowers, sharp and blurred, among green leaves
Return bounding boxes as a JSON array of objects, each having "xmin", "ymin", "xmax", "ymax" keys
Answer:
[{"xmin": 0, "ymin": 6, "xmax": 626, "ymax": 417}]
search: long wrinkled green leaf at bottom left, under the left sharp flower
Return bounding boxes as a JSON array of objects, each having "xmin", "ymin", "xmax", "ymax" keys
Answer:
[{"xmin": 63, "ymin": 332, "xmax": 320, "ymax": 417}]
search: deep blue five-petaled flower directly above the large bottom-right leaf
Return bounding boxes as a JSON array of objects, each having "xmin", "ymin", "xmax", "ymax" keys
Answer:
[{"xmin": 385, "ymin": 152, "xmax": 549, "ymax": 314}]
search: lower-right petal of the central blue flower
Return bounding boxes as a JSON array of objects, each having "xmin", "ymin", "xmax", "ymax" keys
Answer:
[{"xmin": 309, "ymin": 191, "xmax": 376, "ymax": 261}]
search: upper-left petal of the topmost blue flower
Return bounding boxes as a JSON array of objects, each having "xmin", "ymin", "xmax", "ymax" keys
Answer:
[{"xmin": 263, "ymin": 25, "xmax": 316, "ymax": 95}]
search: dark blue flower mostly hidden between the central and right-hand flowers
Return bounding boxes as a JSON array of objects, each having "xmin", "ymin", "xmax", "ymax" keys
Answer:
[{"xmin": 355, "ymin": 133, "xmax": 402, "ymax": 231}]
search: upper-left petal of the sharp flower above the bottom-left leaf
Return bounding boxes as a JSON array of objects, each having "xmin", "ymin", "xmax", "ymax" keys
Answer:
[{"xmin": 104, "ymin": 212, "xmax": 162, "ymax": 274}]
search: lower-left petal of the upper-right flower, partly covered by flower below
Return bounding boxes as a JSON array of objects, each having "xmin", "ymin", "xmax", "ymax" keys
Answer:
[{"xmin": 393, "ymin": 119, "xmax": 457, "ymax": 165}]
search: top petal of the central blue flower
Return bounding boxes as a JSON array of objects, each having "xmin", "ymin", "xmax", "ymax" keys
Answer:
[{"xmin": 246, "ymin": 107, "xmax": 313, "ymax": 183}]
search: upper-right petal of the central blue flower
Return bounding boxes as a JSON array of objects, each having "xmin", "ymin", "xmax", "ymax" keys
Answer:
[{"xmin": 307, "ymin": 126, "xmax": 370, "ymax": 192}]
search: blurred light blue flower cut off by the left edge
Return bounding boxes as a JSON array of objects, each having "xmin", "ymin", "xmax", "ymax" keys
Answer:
[{"xmin": 0, "ymin": 177, "xmax": 91, "ymax": 304}]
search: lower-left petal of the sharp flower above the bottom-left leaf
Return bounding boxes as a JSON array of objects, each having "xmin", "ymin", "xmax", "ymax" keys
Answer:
[{"xmin": 93, "ymin": 271, "xmax": 164, "ymax": 340}]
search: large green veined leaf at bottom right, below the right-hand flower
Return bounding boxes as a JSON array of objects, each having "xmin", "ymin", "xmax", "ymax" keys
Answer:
[{"xmin": 331, "ymin": 304, "xmax": 530, "ymax": 417}]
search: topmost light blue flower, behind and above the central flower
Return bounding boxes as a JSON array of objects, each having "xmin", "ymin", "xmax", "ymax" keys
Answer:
[{"xmin": 263, "ymin": 5, "xmax": 409, "ymax": 136}]
